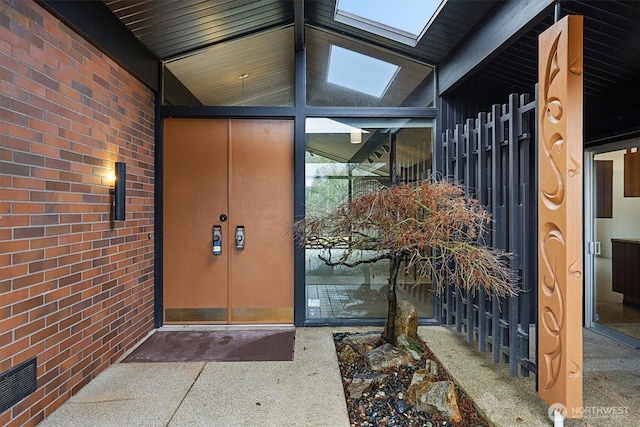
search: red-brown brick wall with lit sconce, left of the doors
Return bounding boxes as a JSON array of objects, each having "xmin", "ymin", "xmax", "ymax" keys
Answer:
[{"xmin": 0, "ymin": 0, "xmax": 154, "ymax": 426}]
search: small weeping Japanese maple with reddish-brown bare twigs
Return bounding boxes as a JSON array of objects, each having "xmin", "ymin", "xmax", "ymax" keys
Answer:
[{"xmin": 294, "ymin": 180, "xmax": 518, "ymax": 343}]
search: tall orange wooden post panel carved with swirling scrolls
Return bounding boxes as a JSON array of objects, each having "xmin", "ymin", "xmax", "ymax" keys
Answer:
[{"xmin": 538, "ymin": 16, "xmax": 583, "ymax": 418}]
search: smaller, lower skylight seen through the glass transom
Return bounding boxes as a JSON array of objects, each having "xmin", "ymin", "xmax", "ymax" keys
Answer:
[{"xmin": 327, "ymin": 45, "xmax": 400, "ymax": 98}]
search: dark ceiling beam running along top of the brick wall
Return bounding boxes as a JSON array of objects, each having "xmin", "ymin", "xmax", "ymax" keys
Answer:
[{"xmin": 38, "ymin": 0, "xmax": 160, "ymax": 91}]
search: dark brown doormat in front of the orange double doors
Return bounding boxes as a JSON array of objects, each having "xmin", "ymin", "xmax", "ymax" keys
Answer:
[{"xmin": 123, "ymin": 329, "xmax": 295, "ymax": 363}]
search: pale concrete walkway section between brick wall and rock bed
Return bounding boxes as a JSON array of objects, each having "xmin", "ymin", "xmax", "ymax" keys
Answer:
[{"xmin": 39, "ymin": 328, "xmax": 349, "ymax": 427}]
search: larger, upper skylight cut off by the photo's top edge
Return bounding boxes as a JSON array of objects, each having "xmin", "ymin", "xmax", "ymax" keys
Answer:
[{"xmin": 334, "ymin": 0, "xmax": 447, "ymax": 46}]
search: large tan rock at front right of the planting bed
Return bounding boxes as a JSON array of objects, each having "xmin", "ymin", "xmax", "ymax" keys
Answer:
[{"xmin": 407, "ymin": 381, "xmax": 462, "ymax": 423}]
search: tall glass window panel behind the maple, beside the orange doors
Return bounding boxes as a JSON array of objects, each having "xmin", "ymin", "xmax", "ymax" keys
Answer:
[{"xmin": 305, "ymin": 118, "xmax": 434, "ymax": 321}]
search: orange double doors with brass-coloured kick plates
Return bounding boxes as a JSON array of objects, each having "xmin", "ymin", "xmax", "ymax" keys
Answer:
[{"xmin": 163, "ymin": 119, "xmax": 293, "ymax": 324}]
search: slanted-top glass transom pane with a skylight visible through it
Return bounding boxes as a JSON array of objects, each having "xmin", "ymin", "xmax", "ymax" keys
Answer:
[{"xmin": 305, "ymin": 27, "xmax": 435, "ymax": 107}]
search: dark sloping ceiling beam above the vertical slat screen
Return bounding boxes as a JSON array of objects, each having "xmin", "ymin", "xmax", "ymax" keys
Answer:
[{"xmin": 438, "ymin": 0, "xmax": 554, "ymax": 96}]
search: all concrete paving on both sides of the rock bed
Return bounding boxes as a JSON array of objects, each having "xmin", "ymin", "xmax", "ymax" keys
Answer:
[{"xmin": 40, "ymin": 327, "xmax": 640, "ymax": 427}]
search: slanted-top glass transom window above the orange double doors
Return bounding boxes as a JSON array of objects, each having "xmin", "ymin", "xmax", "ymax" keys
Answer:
[{"xmin": 163, "ymin": 26, "xmax": 294, "ymax": 106}]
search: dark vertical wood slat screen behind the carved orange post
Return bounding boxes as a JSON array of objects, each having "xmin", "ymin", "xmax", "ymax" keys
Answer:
[{"xmin": 438, "ymin": 87, "xmax": 537, "ymax": 376}]
